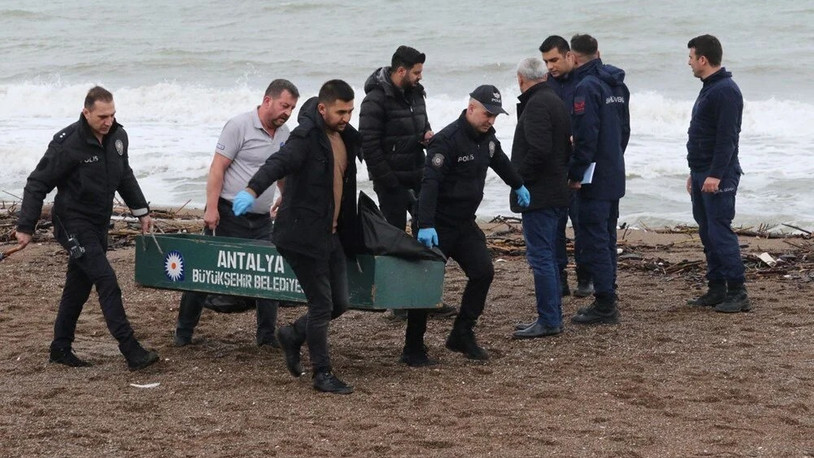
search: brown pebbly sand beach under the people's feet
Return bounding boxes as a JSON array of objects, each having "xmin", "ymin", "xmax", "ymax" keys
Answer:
[{"xmin": 0, "ymin": 212, "xmax": 814, "ymax": 457}]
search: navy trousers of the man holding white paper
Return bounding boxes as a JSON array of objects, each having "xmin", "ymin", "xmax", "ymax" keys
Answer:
[{"xmin": 578, "ymin": 196, "xmax": 619, "ymax": 300}]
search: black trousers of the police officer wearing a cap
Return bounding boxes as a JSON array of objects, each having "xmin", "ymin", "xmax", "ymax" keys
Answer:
[{"xmin": 405, "ymin": 221, "xmax": 495, "ymax": 350}]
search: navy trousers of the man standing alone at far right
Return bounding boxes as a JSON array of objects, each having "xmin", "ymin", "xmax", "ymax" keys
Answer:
[{"xmin": 690, "ymin": 170, "xmax": 744, "ymax": 285}]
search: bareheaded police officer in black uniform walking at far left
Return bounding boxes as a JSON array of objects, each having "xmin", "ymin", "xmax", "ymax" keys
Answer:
[{"xmin": 16, "ymin": 86, "xmax": 158, "ymax": 370}]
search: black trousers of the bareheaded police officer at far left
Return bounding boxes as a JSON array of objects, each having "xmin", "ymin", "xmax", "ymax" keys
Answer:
[{"xmin": 51, "ymin": 223, "xmax": 135, "ymax": 355}]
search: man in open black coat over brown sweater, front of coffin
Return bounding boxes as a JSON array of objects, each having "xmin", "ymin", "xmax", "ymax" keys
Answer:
[{"xmin": 232, "ymin": 80, "xmax": 360, "ymax": 394}]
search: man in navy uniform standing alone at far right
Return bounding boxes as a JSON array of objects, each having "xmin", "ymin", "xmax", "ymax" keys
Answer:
[{"xmin": 687, "ymin": 35, "xmax": 751, "ymax": 313}]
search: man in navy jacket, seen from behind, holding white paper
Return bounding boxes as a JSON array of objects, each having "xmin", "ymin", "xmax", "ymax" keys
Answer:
[{"xmin": 568, "ymin": 35, "xmax": 630, "ymax": 324}]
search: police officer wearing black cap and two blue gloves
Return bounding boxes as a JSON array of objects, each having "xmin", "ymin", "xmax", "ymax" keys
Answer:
[{"xmin": 418, "ymin": 85, "xmax": 530, "ymax": 360}]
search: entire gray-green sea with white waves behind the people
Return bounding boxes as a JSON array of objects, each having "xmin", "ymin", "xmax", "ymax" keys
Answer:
[{"xmin": 0, "ymin": 0, "xmax": 814, "ymax": 229}]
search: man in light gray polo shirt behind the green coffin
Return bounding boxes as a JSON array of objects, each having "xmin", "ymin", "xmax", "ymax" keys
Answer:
[{"xmin": 173, "ymin": 79, "xmax": 300, "ymax": 347}]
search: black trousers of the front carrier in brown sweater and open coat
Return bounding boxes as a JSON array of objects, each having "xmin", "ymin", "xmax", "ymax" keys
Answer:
[{"xmin": 277, "ymin": 234, "xmax": 349, "ymax": 373}]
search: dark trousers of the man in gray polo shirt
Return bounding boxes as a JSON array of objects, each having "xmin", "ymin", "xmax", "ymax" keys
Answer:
[{"xmin": 175, "ymin": 199, "xmax": 278, "ymax": 344}]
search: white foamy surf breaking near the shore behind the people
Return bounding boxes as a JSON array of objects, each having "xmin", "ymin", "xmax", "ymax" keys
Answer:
[{"xmin": 0, "ymin": 81, "xmax": 814, "ymax": 225}]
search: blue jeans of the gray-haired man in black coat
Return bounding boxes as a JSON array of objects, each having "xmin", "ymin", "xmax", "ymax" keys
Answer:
[{"xmin": 523, "ymin": 208, "xmax": 567, "ymax": 327}]
